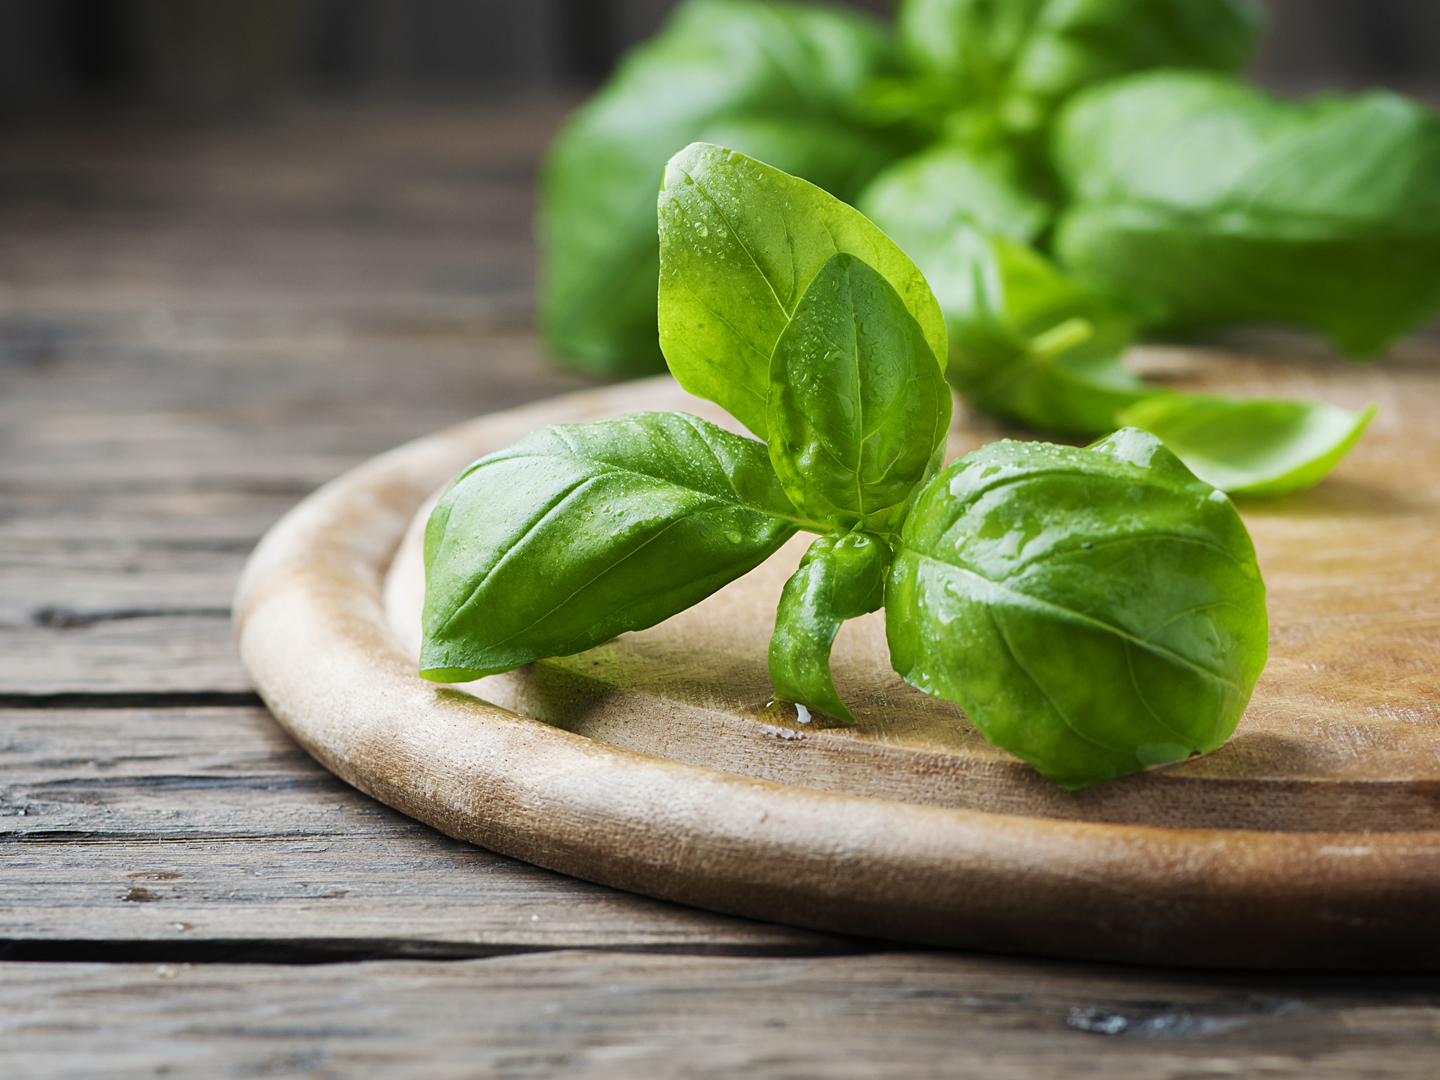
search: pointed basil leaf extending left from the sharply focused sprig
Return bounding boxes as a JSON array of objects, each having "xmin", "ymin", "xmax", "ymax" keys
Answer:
[{"xmin": 420, "ymin": 413, "xmax": 815, "ymax": 683}]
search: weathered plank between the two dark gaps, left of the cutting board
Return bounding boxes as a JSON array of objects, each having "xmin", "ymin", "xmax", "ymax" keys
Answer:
[{"xmin": 0, "ymin": 708, "xmax": 851, "ymax": 956}]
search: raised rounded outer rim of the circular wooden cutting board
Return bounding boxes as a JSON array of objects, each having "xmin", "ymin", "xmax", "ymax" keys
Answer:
[{"xmin": 236, "ymin": 380, "xmax": 1440, "ymax": 968}]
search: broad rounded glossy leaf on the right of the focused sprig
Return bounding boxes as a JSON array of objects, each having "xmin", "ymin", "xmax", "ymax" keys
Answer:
[{"xmin": 886, "ymin": 428, "xmax": 1267, "ymax": 788}]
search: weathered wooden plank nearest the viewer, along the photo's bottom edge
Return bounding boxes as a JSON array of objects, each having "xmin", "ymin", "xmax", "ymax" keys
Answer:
[{"xmin": 0, "ymin": 953, "xmax": 1440, "ymax": 1080}]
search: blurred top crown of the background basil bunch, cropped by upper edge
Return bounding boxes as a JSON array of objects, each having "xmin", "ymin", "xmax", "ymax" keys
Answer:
[{"xmin": 897, "ymin": 0, "xmax": 1263, "ymax": 135}]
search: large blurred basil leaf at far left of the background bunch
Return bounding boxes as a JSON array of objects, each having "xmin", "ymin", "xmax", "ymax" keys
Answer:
[{"xmin": 539, "ymin": 0, "xmax": 896, "ymax": 372}]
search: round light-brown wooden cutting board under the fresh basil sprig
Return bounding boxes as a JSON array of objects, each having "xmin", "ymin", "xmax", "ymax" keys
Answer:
[{"xmin": 236, "ymin": 350, "xmax": 1440, "ymax": 968}]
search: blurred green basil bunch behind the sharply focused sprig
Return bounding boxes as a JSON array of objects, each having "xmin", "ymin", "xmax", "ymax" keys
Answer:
[{"xmin": 540, "ymin": 0, "xmax": 1416, "ymax": 495}]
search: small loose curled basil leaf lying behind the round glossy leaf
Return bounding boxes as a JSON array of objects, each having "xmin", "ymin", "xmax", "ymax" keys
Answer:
[{"xmin": 1119, "ymin": 393, "xmax": 1377, "ymax": 495}]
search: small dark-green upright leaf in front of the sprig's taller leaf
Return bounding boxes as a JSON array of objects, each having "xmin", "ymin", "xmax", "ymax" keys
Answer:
[{"xmin": 769, "ymin": 255, "xmax": 950, "ymax": 533}]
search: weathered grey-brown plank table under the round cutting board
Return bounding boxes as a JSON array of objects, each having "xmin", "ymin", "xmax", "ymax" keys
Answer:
[{"xmin": 0, "ymin": 99, "xmax": 1440, "ymax": 1079}]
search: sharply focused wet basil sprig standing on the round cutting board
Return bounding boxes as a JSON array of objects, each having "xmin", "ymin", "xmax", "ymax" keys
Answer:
[{"xmin": 420, "ymin": 144, "xmax": 1267, "ymax": 788}]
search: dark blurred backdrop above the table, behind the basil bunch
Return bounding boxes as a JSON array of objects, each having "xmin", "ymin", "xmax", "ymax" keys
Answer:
[{"xmin": 0, "ymin": 0, "xmax": 1440, "ymax": 117}]
